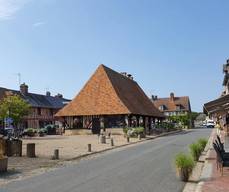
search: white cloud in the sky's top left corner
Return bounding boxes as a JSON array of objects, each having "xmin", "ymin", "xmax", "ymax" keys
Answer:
[{"xmin": 0, "ymin": 0, "xmax": 30, "ymax": 20}]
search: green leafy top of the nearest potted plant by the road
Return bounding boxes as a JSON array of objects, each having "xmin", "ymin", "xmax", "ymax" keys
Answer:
[{"xmin": 175, "ymin": 153, "xmax": 195, "ymax": 172}]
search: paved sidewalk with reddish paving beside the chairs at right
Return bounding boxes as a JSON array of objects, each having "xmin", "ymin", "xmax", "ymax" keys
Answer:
[{"xmin": 184, "ymin": 129, "xmax": 229, "ymax": 192}]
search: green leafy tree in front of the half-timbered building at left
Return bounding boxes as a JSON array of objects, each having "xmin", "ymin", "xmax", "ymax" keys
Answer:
[{"xmin": 0, "ymin": 95, "xmax": 30, "ymax": 128}]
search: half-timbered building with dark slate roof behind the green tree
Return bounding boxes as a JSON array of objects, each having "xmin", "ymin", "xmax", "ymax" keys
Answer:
[{"xmin": 0, "ymin": 83, "xmax": 70, "ymax": 128}]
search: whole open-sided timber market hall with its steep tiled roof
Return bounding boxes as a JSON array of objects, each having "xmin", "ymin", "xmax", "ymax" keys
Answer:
[{"xmin": 56, "ymin": 65, "xmax": 164, "ymax": 133}]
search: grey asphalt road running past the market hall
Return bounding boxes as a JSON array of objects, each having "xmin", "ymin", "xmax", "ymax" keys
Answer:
[{"xmin": 0, "ymin": 129, "xmax": 211, "ymax": 192}]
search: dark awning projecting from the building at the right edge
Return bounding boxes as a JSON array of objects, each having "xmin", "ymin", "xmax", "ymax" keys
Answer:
[{"xmin": 204, "ymin": 94, "xmax": 229, "ymax": 114}]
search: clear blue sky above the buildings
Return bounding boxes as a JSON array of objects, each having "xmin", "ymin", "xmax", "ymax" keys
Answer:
[{"xmin": 0, "ymin": 0, "xmax": 229, "ymax": 111}]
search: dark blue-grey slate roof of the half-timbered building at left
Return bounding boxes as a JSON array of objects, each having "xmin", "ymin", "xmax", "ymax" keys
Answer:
[{"xmin": 0, "ymin": 87, "xmax": 70, "ymax": 109}]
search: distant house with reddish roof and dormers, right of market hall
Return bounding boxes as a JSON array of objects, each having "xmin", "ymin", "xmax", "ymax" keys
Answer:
[{"xmin": 151, "ymin": 93, "xmax": 191, "ymax": 116}]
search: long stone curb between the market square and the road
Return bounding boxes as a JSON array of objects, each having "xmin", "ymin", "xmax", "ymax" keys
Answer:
[{"xmin": 63, "ymin": 130, "xmax": 183, "ymax": 161}]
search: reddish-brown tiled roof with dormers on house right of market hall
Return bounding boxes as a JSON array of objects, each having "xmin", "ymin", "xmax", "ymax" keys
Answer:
[{"xmin": 152, "ymin": 96, "xmax": 191, "ymax": 112}]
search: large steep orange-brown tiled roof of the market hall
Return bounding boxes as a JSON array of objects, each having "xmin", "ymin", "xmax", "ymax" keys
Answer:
[{"xmin": 56, "ymin": 65, "xmax": 164, "ymax": 117}]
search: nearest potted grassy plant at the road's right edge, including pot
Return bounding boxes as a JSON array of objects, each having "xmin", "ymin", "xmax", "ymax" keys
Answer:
[{"xmin": 175, "ymin": 153, "xmax": 195, "ymax": 182}]
